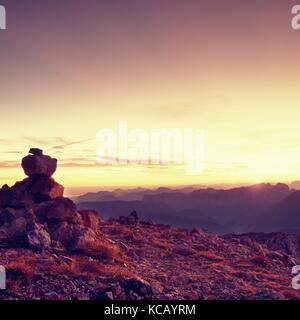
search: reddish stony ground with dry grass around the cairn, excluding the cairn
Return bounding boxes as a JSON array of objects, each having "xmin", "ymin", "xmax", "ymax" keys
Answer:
[{"xmin": 0, "ymin": 218, "xmax": 300, "ymax": 300}]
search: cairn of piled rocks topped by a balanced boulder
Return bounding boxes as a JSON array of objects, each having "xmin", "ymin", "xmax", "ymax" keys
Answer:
[{"xmin": 0, "ymin": 148, "xmax": 99, "ymax": 251}]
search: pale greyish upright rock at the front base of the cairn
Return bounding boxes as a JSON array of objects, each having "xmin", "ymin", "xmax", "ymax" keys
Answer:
[{"xmin": 27, "ymin": 224, "xmax": 51, "ymax": 251}]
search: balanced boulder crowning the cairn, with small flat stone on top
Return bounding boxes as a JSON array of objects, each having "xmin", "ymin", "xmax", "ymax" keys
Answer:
[{"xmin": 22, "ymin": 149, "xmax": 57, "ymax": 177}]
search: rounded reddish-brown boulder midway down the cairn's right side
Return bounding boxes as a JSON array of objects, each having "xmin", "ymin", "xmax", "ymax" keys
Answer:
[{"xmin": 45, "ymin": 197, "xmax": 77, "ymax": 223}]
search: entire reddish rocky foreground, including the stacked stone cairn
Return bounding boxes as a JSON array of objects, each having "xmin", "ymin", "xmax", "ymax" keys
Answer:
[{"xmin": 0, "ymin": 148, "xmax": 300, "ymax": 300}]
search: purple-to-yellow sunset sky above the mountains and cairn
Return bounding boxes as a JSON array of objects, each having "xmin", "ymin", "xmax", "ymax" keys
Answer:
[{"xmin": 0, "ymin": 0, "xmax": 300, "ymax": 192}]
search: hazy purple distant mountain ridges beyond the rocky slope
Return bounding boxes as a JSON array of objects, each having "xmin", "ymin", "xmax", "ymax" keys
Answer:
[{"xmin": 75, "ymin": 183, "xmax": 300, "ymax": 234}]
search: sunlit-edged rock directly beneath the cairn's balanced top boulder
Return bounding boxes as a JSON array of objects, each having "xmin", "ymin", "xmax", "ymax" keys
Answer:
[{"xmin": 30, "ymin": 176, "xmax": 64, "ymax": 201}]
